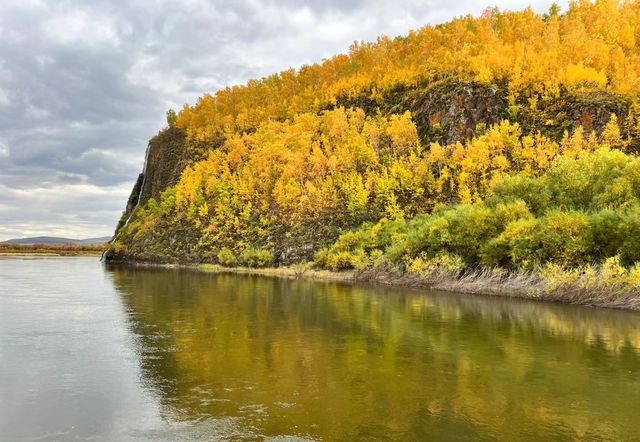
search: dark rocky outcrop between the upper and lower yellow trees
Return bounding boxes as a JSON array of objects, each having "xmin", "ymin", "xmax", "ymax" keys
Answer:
[{"xmin": 337, "ymin": 77, "xmax": 631, "ymax": 146}]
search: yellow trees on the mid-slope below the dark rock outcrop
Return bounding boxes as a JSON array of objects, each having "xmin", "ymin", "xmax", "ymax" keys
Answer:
[{"xmin": 134, "ymin": 108, "xmax": 633, "ymax": 258}]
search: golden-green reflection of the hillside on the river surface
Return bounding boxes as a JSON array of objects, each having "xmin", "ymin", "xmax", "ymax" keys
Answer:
[{"xmin": 113, "ymin": 268, "xmax": 640, "ymax": 440}]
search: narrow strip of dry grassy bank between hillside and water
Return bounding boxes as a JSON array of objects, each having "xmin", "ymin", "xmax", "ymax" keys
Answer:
[{"xmin": 107, "ymin": 261, "xmax": 640, "ymax": 311}]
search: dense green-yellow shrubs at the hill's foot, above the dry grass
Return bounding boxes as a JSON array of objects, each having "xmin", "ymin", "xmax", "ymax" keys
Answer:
[{"xmin": 315, "ymin": 149, "xmax": 640, "ymax": 272}]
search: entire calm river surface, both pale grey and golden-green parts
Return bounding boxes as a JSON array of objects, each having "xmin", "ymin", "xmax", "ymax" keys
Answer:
[{"xmin": 0, "ymin": 258, "xmax": 640, "ymax": 441}]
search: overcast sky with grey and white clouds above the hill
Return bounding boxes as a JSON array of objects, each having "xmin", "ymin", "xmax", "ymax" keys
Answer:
[{"xmin": 0, "ymin": 0, "xmax": 567, "ymax": 241}]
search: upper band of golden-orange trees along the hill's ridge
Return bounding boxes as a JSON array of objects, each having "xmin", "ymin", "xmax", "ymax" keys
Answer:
[{"xmin": 175, "ymin": 0, "xmax": 640, "ymax": 142}]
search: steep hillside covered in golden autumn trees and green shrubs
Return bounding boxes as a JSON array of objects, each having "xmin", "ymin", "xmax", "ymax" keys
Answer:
[{"xmin": 107, "ymin": 0, "xmax": 640, "ymax": 300}]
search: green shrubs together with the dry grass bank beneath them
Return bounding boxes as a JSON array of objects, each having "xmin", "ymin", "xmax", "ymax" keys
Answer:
[{"xmin": 314, "ymin": 147, "xmax": 640, "ymax": 310}]
